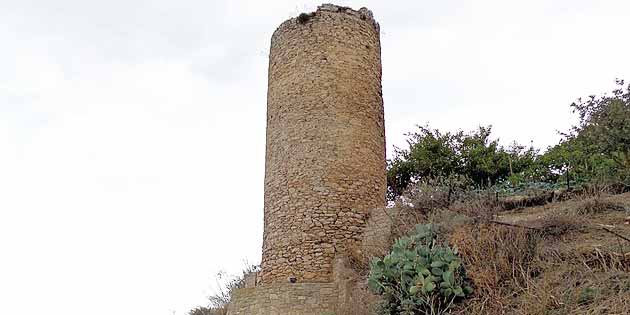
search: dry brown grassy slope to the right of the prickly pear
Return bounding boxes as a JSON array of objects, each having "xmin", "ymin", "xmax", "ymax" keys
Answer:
[{"xmin": 349, "ymin": 190, "xmax": 630, "ymax": 315}]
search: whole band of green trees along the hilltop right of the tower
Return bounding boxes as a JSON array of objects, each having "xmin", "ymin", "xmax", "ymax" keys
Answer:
[{"xmin": 387, "ymin": 80, "xmax": 630, "ymax": 200}]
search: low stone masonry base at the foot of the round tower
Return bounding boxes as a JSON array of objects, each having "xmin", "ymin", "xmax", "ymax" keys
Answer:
[{"xmin": 228, "ymin": 283, "xmax": 338, "ymax": 315}]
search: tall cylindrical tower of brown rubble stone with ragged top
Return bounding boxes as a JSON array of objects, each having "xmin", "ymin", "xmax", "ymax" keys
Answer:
[{"xmin": 261, "ymin": 5, "xmax": 386, "ymax": 283}]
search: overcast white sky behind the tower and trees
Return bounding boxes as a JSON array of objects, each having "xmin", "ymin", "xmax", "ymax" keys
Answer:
[{"xmin": 0, "ymin": 0, "xmax": 630, "ymax": 315}]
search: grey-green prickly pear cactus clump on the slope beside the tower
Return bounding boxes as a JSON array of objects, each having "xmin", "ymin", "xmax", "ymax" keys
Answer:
[{"xmin": 368, "ymin": 224, "xmax": 472, "ymax": 315}]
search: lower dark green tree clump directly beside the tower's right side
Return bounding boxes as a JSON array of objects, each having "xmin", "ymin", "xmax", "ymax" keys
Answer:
[{"xmin": 387, "ymin": 126, "xmax": 539, "ymax": 200}]
